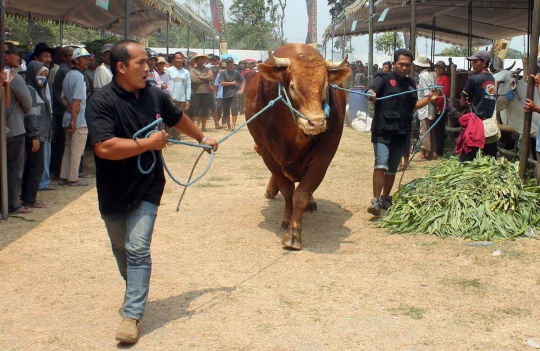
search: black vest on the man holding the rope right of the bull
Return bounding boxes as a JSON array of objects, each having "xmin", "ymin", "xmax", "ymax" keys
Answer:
[{"xmin": 371, "ymin": 72, "xmax": 417, "ymax": 134}]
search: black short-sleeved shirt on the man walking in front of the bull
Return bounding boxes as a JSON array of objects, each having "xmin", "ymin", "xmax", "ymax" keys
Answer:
[{"xmin": 86, "ymin": 79, "xmax": 183, "ymax": 214}]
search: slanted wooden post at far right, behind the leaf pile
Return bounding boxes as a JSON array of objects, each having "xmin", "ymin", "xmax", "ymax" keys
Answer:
[{"xmin": 518, "ymin": 0, "xmax": 540, "ymax": 181}]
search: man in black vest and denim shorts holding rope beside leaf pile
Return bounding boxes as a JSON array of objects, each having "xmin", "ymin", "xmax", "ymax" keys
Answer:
[{"xmin": 367, "ymin": 49, "xmax": 439, "ymax": 216}]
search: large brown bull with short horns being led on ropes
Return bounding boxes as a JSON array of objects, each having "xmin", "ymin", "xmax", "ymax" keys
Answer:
[{"xmin": 246, "ymin": 44, "xmax": 351, "ymax": 250}]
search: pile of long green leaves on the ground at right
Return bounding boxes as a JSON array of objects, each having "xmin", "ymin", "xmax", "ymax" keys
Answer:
[{"xmin": 381, "ymin": 156, "xmax": 540, "ymax": 240}]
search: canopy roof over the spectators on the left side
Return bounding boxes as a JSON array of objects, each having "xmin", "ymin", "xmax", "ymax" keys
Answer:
[{"xmin": 6, "ymin": 0, "xmax": 214, "ymax": 38}]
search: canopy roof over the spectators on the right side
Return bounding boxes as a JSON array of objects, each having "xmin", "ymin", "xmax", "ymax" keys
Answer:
[{"xmin": 323, "ymin": 0, "xmax": 529, "ymax": 46}]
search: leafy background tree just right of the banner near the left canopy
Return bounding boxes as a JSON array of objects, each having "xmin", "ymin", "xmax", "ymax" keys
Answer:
[{"xmin": 227, "ymin": 0, "xmax": 279, "ymax": 50}]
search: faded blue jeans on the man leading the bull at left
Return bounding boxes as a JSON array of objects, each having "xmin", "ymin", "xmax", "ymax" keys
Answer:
[{"xmin": 101, "ymin": 201, "xmax": 157, "ymax": 320}]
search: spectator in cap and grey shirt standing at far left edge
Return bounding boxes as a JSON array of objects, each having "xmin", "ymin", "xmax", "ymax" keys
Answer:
[{"xmin": 2, "ymin": 43, "xmax": 32, "ymax": 214}]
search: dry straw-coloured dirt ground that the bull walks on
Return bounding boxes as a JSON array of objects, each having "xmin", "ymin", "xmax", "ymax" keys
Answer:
[{"xmin": 0, "ymin": 124, "xmax": 540, "ymax": 351}]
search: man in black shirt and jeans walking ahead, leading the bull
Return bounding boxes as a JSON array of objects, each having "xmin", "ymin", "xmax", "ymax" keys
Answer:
[{"xmin": 86, "ymin": 40, "xmax": 218, "ymax": 343}]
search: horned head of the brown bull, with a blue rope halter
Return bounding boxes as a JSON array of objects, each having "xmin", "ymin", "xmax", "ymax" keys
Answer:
[{"xmin": 258, "ymin": 51, "xmax": 351, "ymax": 135}]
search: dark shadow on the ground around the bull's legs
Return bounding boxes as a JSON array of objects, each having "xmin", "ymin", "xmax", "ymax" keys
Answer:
[{"xmin": 259, "ymin": 194, "xmax": 353, "ymax": 254}]
